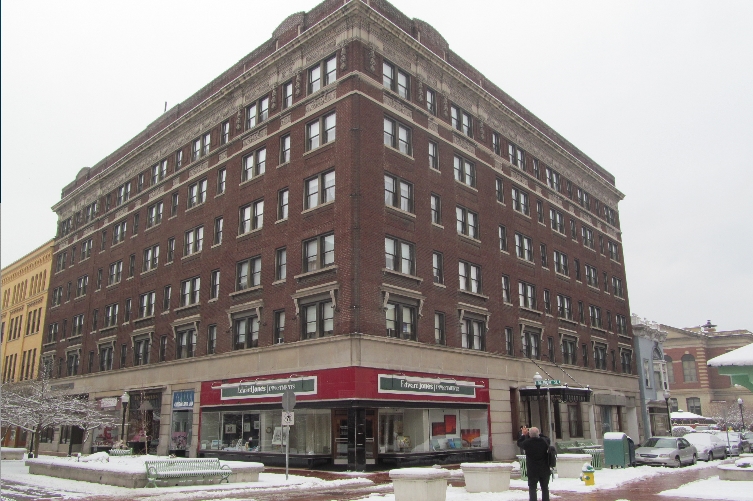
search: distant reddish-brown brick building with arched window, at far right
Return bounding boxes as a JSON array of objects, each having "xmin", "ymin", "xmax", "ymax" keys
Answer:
[{"xmin": 661, "ymin": 321, "xmax": 753, "ymax": 417}]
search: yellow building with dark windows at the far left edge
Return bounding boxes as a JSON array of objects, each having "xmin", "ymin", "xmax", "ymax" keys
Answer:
[{"xmin": 0, "ymin": 240, "xmax": 54, "ymax": 447}]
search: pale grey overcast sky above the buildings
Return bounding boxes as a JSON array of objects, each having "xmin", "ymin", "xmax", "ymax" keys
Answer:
[{"xmin": 0, "ymin": 0, "xmax": 753, "ymax": 330}]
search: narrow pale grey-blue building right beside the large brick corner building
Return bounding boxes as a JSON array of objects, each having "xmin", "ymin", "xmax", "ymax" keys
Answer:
[{"xmin": 630, "ymin": 315, "xmax": 670, "ymax": 442}]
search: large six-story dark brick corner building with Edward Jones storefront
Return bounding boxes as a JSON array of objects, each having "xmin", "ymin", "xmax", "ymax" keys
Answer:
[{"xmin": 43, "ymin": 0, "xmax": 638, "ymax": 469}]
